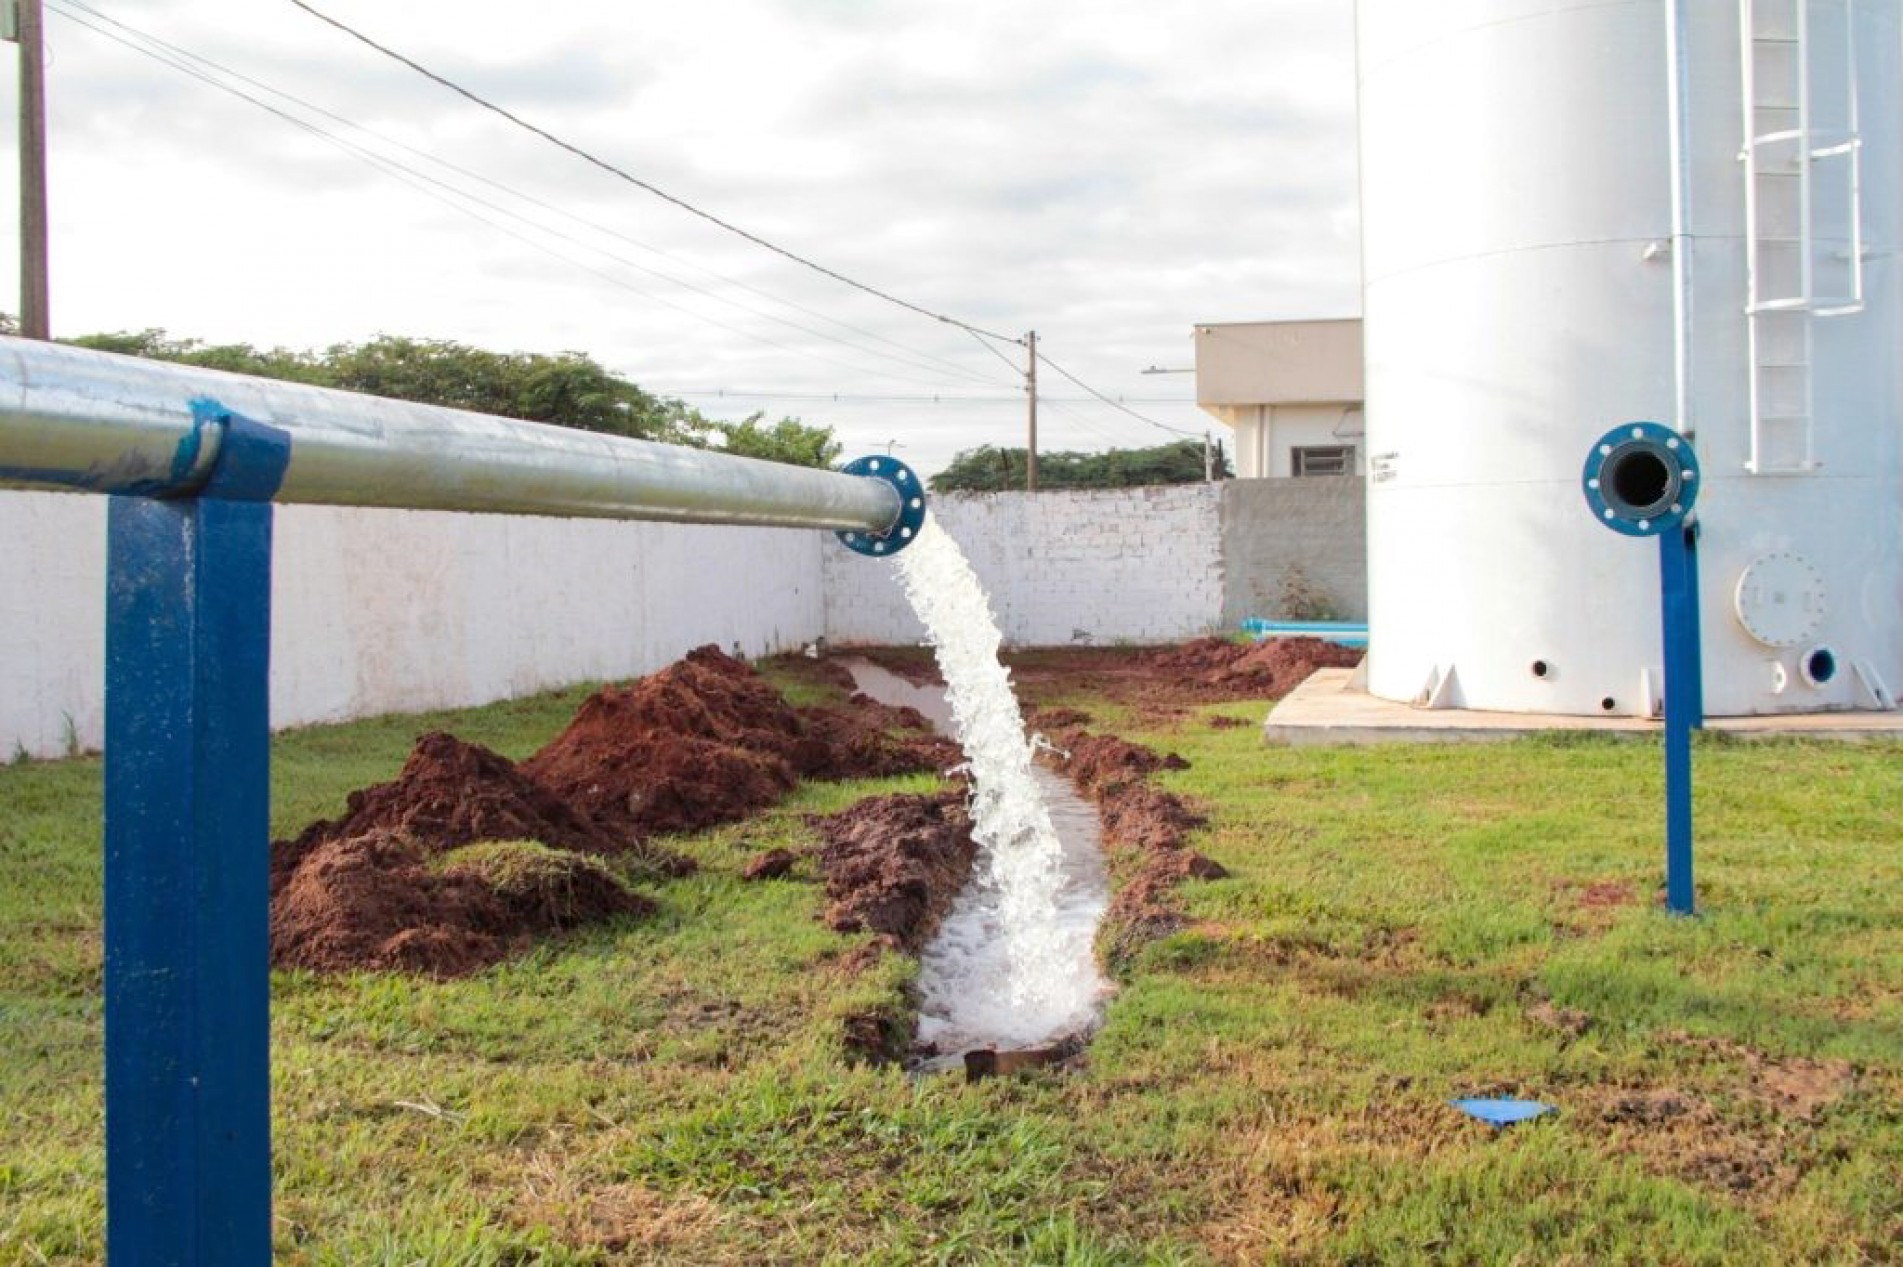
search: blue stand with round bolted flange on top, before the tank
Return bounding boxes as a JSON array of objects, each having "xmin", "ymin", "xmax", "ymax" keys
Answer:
[{"xmin": 1579, "ymin": 422, "xmax": 1705, "ymax": 915}]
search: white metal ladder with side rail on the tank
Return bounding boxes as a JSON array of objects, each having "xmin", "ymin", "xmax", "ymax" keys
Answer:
[{"xmin": 1739, "ymin": 0, "xmax": 1863, "ymax": 474}]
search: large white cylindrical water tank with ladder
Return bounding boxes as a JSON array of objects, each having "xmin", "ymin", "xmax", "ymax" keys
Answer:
[{"xmin": 1357, "ymin": 0, "xmax": 1903, "ymax": 715}]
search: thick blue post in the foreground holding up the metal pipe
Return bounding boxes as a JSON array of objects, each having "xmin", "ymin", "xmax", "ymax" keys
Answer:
[{"xmin": 105, "ymin": 407, "xmax": 289, "ymax": 1267}]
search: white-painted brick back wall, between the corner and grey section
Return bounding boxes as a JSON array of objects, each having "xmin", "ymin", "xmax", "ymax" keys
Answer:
[{"xmin": 822, "ymin": 483, "xmax": 1224, "ymax": 647}]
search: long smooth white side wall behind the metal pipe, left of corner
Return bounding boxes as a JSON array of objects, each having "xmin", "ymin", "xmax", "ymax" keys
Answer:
[{"xmin": 0, "ymin": 493, "xmax": 837, "ymax": 759}]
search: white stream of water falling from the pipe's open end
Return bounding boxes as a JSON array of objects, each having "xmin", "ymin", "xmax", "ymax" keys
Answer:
[{"xmin": 898, "ymin": 517, "xmax": 1106, "ymax": 1037}]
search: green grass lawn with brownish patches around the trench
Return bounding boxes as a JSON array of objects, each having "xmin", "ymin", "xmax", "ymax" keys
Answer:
[{"xmin": 0, "ymin": 665, "xmax": 1903, "ymax": 1265}]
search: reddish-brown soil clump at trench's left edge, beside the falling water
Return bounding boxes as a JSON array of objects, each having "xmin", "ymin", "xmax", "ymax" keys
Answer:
[{"xmin": 813, "ymin": 791, "xmax": 978, "ymax": 949}]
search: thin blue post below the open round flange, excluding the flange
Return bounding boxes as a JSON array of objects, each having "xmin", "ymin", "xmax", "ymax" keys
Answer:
[{"xmin": 1659, "ymin": 519, "xmax": 1705, "ymax": 915}]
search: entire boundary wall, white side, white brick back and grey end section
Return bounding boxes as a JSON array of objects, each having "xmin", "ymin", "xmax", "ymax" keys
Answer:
[{"xmin": 0, "ymin": 479, "xmax": 1364, "ymax": 759}]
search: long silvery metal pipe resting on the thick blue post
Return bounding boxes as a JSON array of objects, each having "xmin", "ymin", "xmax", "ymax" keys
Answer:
[{"xmin": 0, "ymin": 337, "xmax": 906, "ymax": 535}]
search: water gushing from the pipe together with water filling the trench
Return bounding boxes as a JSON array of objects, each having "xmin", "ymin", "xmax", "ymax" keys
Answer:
[{"xmin": 854, "ymin": 517, "xmax": 1109, "ymax": 1054}]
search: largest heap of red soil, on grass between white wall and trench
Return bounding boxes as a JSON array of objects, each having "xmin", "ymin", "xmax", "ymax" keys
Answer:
[{"xmin": 270, "ymin": 647, "xmax": 957, "ymax": 976}]
